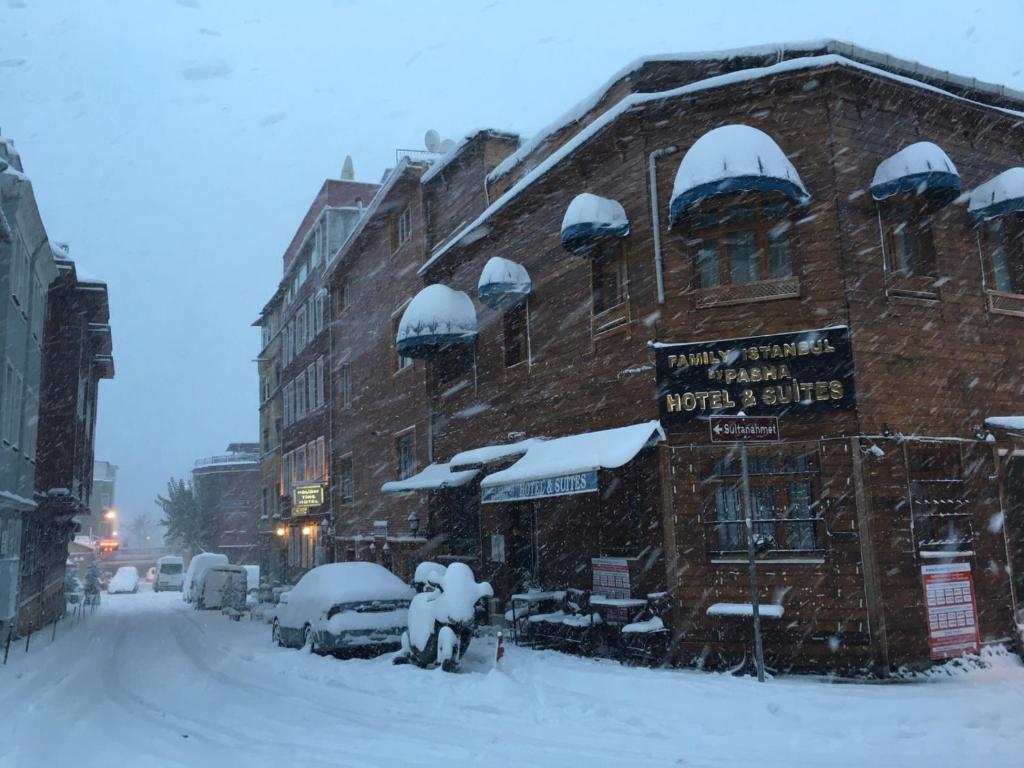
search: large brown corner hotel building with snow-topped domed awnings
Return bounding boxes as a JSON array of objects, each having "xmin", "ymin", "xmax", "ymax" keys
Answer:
[{"xmin": 253, "ymin": 42, "xmax": 1024, "ymax": 675}]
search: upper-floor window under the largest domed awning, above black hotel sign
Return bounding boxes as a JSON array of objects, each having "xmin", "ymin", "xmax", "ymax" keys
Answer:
[{"xmin": 688, "ymin": 201, "xmax": 793, "ymax": 288}]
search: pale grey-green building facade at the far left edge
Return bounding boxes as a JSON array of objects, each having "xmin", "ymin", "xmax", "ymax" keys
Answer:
[{"xmin": 0, "ymin": 138, "xmax": 56, "ymax": 636}]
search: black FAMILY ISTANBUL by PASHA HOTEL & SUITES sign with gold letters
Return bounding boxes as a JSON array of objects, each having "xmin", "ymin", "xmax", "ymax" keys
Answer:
[{"xmin": 655, "ymin": 326, "xmax": 857, "ymax": 428}]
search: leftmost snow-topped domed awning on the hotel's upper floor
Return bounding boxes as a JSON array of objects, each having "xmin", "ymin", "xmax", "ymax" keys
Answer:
[{"xmin": 395, "ymin": 284, "xmax": 476, "ymax": 357}]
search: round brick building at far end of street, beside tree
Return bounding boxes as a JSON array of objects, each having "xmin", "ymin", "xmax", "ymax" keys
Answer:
[{"xmin": 191, "ymin": 442, "xmax": 260, "ymax": 565}]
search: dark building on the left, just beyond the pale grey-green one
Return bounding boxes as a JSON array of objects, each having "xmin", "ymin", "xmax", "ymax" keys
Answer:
[{"xmin": 18, "ymin": 248, "xmax": 114, "ymax": 633}]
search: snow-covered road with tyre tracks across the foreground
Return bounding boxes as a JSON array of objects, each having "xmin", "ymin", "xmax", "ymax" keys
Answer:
[{"xmin": 0, "ymin": 592, "xmax": 1024, "ymax": 768}]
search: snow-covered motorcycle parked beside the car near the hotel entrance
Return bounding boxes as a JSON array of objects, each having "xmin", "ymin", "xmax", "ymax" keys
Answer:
[{"xmin": 395, "ymin": 562, "xmax": 495, "ymax": 672}]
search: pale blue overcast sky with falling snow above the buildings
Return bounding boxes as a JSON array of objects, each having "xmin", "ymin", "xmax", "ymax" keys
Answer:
[{"xmin": 0, "ymin": 0, "xmax": 1024, "ymax": 518}]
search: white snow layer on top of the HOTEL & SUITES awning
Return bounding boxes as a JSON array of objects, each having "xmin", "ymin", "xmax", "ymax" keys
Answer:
[{"xmin": 480, "ymin": 421, "xmax": 665, "ymax": 487}]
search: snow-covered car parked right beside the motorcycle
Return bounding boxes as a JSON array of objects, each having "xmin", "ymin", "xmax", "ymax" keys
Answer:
[{"xmin": 273, "ymin": 562, "xmax": 416, "ymax": 654}]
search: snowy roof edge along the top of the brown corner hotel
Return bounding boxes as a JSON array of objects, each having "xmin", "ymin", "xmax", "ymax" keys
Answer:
[{"xmin": 418, "ymin": 50, "xmax": 1024, "ymax": 274}]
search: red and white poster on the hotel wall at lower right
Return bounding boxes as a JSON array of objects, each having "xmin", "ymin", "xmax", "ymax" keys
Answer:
[{"xmin": 921, "ymin": 562, "xmax": 981, "ymax": 658}]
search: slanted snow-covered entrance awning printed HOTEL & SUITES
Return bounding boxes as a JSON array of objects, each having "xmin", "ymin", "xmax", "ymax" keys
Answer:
[{"xmin": 480, "ymin": 421, "xmax": 665, "ymax": 504}]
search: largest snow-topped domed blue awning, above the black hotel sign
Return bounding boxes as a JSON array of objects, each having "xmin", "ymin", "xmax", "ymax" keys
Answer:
[{"xmin": 669, "ymin": 125, "xmax": 811, "ymax": 224}]
